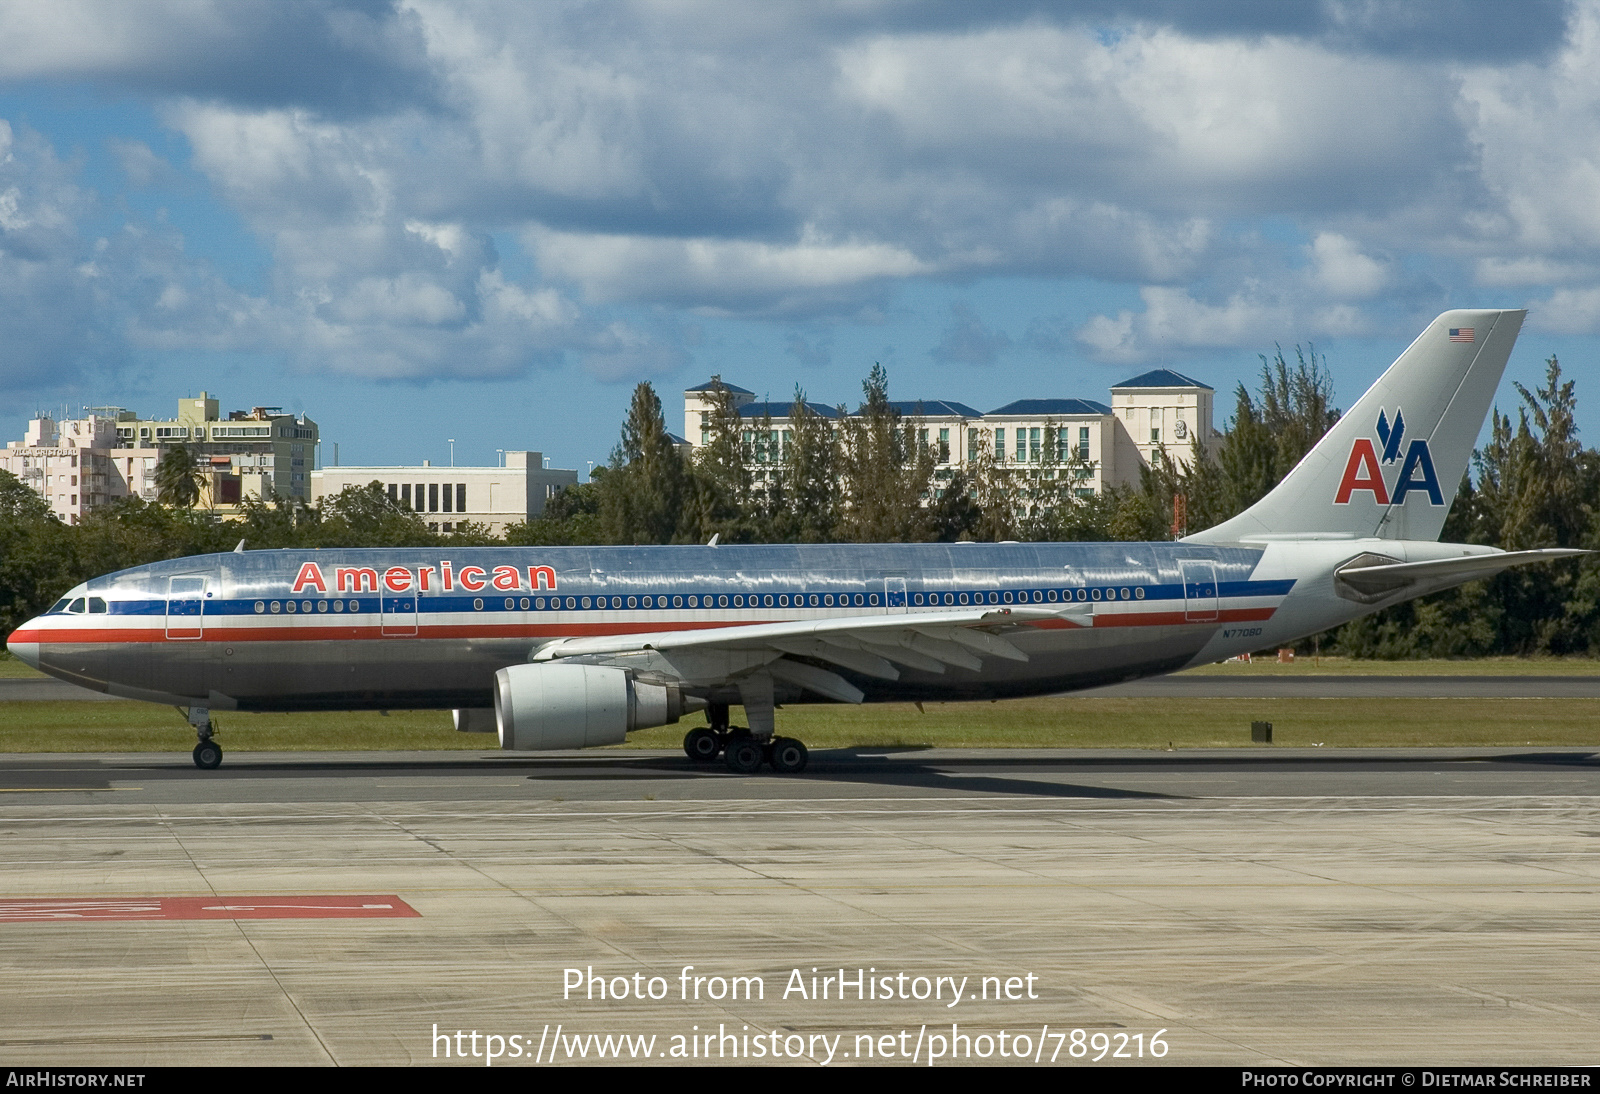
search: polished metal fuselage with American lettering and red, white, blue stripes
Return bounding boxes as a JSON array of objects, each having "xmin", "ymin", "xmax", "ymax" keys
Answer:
[{"xmin": 11, "ymin": 542, "xmax": 1312, "ymax": 710}]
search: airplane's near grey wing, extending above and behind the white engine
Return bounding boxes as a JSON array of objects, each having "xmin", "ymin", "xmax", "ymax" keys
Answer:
[{"xmin": 533, "ymin": 603, "xmax": 1093, "ymax": 702}]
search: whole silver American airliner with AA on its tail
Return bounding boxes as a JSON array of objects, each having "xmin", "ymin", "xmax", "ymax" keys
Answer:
[{"xmin": 8, "ymin": 303, "xmax": 1584, "ymax": 774}]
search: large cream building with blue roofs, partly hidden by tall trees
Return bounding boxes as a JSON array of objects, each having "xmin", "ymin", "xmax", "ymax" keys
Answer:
[{"xmin": 683, "ymin": 369, "xmax": 1216, "ymax": 494}]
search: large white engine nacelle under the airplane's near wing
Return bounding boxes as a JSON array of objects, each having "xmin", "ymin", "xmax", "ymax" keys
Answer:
[{"xmin": 494, "ymin": 662, "xmax": 704, "ymax": 752}]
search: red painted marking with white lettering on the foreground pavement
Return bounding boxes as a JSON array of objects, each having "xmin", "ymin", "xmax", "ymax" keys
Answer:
[{"xmin": 0, "ymin": 894, "xmax": 421, "ymax": 923}]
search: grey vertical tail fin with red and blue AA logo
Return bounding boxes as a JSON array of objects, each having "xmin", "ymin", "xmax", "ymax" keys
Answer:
[{"xmin": 1189, "ymin": 310, "xmax": 1526, "ymax": 544}]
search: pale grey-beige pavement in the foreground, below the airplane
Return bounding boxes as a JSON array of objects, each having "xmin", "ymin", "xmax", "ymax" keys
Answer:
[{"xmin": 0, "ymin": 749, "xmax": 1600, "ymax": 1067}]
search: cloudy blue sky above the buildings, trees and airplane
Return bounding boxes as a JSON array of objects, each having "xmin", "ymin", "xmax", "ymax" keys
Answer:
[{"xmin": 0, "ymin": 0, "xmax": 1600, "ymax": 472}]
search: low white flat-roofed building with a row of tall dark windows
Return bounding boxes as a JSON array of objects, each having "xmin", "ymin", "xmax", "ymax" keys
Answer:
[{"xmin": 312, "ymin": 451, "xmax": 578, "ymax": 536}]
